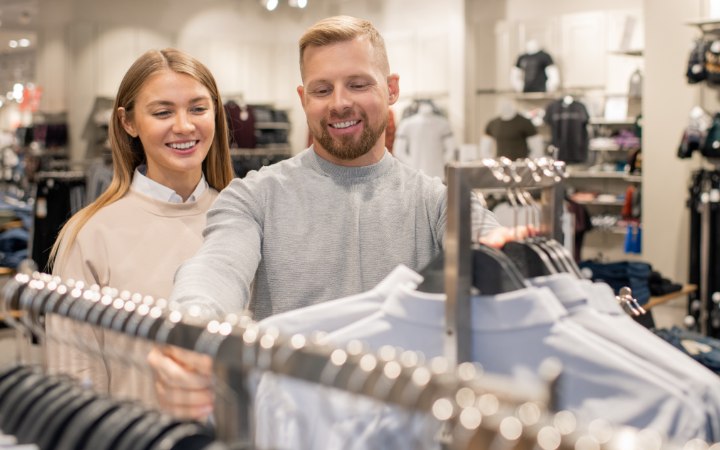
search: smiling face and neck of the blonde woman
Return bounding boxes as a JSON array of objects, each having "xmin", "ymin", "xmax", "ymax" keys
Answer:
[{"xmin": 119, "ymin": 70, "xmax": 215, "ymax": 192}]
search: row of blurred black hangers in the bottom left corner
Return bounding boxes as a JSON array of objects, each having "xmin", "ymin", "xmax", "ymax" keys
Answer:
[{"xmin": 0, "ymin": 365, "xmax": 221, "ymax": 450}]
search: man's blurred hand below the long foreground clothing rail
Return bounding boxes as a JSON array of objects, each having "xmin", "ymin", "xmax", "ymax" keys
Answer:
[{"xmin": 147, "ymin": 346, "xmax": 215, "ymax": 421}]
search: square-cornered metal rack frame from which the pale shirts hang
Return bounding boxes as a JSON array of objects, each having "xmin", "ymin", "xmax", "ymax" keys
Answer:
[{"xmin": 445, "ymin": 158, "xmax": 565, "ymax": 363}]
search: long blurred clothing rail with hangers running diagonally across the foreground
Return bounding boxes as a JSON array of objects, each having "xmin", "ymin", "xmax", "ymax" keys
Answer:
[{"xmin": 0, "ymin": 272, "xmax": 676, "ymax": 450}]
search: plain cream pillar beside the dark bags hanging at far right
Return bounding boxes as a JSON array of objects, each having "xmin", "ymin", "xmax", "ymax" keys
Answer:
[{"xmin": 642, "ymin": 0, "xmax": 701, "ymax": 281}]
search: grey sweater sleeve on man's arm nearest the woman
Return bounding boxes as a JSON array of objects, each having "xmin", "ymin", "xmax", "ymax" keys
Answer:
[{"xmin": 170, "ymin": 176, "xmax": 264, "ymax": 317}]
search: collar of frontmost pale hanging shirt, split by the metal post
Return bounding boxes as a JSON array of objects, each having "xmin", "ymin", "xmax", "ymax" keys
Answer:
[{"xmin": 382, "ymin": 287, "xmax": 567, "ymax": 331}]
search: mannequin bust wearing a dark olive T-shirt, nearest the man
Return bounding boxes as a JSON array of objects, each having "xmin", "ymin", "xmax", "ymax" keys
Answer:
[{"xmin": 479, "ymin": 99, "xmax": 544, "ymax": 159}]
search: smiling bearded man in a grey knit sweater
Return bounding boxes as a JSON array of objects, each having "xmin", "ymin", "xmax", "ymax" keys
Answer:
[{"xmin": 151, "ymin": 16, "xmax": 497, "ymax": 416}]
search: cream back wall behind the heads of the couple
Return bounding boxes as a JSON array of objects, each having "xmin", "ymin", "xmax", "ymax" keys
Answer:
[{"xmin": 33, "ymin": 0, "xmax": 465, "ymax": 160}]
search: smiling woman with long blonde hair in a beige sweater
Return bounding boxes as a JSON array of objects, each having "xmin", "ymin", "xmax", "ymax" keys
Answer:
[{"xmin": 48, "ymin": 49, "xmax": 233, "ymax": 404}]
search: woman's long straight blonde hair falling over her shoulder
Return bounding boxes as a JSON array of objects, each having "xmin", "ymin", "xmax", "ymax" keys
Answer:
[{"xmin": 48, "ymin": 48, "xmax": 233, "ymax": 269}]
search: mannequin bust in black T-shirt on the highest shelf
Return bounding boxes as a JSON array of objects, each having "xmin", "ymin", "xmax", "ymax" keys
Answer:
[{"xmin": 510, "ymin": 39, "xmax": 560, "ymax": 92}]
